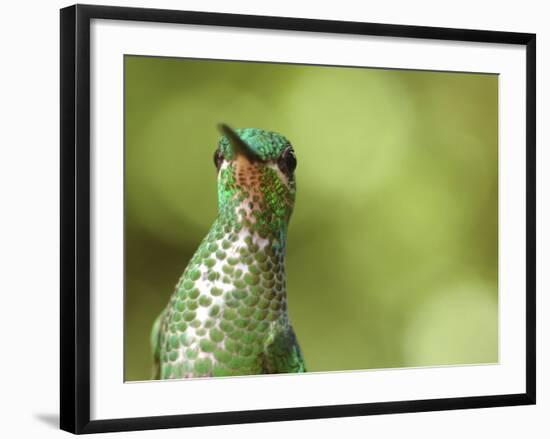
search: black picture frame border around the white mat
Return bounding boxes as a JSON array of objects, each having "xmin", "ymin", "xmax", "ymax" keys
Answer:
[{"xmin": 60, "ymin": 5, "xmax": 536, "ymax": 434}]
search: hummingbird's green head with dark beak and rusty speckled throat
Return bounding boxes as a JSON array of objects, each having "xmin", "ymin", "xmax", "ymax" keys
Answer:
[{"xmin": 214, "ymin": 124, "xmax": 297, "ymax": 241}]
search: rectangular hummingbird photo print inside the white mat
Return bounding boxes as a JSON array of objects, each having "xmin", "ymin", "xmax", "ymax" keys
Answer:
[{"xmin": 124, "ymin": 55, "xmax": 499, "ymax": 381}]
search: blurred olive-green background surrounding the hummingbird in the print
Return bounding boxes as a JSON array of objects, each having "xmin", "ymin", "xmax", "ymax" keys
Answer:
[{"xmin": 124, "ymin": 56, "xmax": 498, "ymax": 380}]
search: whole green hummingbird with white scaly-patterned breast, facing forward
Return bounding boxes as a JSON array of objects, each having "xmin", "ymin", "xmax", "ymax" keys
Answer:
[{"xmin": 151, "ymin": 124, "xmax": 306, "ymax": 379}]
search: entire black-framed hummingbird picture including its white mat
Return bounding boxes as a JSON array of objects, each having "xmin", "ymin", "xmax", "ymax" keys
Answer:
[{"xmin": 61, "ymin": 5, "xmax": 535, "ymax": 433}]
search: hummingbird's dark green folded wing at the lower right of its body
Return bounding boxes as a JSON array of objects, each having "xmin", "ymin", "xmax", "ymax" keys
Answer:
[{"xmin": 264, "ymin": 325, "xmax": 306, "ymax": 373}]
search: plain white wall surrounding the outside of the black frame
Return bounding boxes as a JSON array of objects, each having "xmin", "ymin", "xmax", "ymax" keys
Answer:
[{"xmin": 0, "ymin": 0, "xmax": 550, "ymax": 438}]
